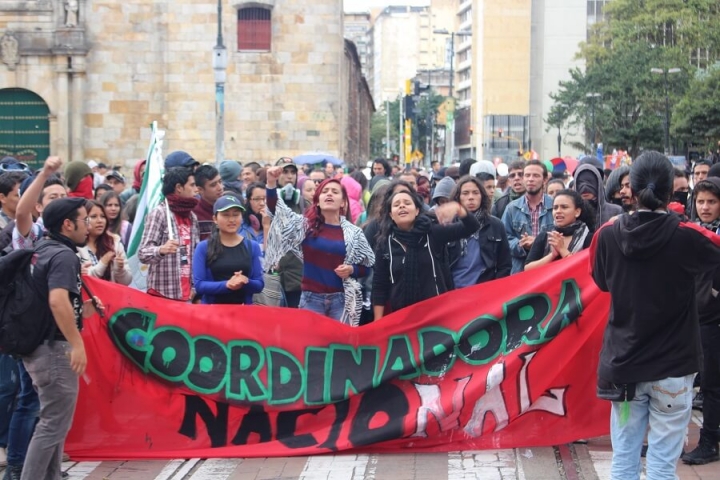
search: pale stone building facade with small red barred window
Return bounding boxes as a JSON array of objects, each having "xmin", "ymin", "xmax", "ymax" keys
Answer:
[{"xmin": 0, "ymin": 0, "xmax": 372, "ymax": 170}]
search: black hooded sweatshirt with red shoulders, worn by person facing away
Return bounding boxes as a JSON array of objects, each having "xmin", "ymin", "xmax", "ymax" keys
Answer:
[{"xmin": 590, "ymin": 211, "xmax": 720, "ymax": 384}]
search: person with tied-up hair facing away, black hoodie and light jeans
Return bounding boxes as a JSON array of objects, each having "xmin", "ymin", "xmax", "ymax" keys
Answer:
[{"xmin": 590, "ymin": 151, "xmax": 720, "ymax": 480}]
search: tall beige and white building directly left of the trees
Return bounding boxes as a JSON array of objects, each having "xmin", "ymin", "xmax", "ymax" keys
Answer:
[{"xmin": 470, "ymin": 0, "xmax": 610, "ymax": 161}]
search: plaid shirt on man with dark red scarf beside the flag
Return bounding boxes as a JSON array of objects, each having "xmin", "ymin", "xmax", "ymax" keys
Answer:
[{"xmin": 138, "ymin": 202, "xmax": 200, "ymax": 300}]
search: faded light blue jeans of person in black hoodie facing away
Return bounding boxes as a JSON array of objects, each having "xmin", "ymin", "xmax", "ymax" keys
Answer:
[{"xmin": 610, "ymin": 375, "xmax": 693, "ymax": 480}]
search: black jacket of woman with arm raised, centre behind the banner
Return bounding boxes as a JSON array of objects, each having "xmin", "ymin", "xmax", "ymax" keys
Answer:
[{"xmin": 372, "ymin": 215, "xmax": 480, "ymax": 312}]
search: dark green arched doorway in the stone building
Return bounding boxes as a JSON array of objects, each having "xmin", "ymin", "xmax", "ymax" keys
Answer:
[{"xmin": 0, "ymin": 88, "xmax": 50, "ymax": 168}]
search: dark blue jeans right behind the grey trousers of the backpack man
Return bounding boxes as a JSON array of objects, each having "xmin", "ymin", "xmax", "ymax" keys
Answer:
[{"xmin": 7, "ymin": 362, "xmax": 40, "ymax": 465}]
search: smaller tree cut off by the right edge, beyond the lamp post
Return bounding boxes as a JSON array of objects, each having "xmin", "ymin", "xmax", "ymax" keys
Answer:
[{"xmin": 671, "ymin": 64, "xmax": 720, "ymax": 150}]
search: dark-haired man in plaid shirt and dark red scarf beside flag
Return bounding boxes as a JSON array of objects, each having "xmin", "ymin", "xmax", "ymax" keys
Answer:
[{"xmin": 138, "ymin": 167, "xmax": 200, "ymax": 302}]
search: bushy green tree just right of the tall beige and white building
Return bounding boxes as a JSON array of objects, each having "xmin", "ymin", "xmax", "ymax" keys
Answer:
[{"xmin": 548, "ymin": 43, "xmax": 688, "ymax": 156}]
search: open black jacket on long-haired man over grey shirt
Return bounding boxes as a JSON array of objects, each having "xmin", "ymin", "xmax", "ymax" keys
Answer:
[{"xmin": 448, "ymin": 215, "xmax": 512, "ymax": 283}]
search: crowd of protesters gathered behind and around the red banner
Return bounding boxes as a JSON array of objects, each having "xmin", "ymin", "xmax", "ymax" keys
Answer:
[{"xmin": 0, "ymin": 151, "xmax": 720, "ymax": 479}]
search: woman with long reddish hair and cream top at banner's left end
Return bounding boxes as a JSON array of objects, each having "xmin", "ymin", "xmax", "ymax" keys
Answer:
[{"xmin": 78, "ymin": 200, "xmax": 132, "ymax": 285}]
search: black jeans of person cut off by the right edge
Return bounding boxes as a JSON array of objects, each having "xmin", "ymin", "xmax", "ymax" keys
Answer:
[{"xmin": 700, "ymin": 323, "xmax": 720, "ymax": 436}]
